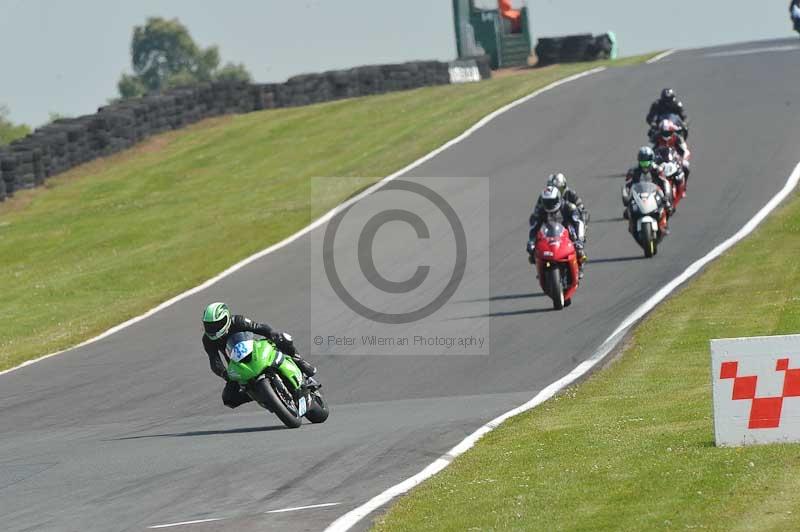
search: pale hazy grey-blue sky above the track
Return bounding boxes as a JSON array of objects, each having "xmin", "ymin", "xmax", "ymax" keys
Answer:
[{"xmin": 0, "ymin": 0, "xmax": 796, "ymax": 126}]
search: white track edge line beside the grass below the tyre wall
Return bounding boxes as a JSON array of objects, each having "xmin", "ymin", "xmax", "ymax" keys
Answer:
[{"xmin": 0, "ymin": 67, "xmax": 606, "ymax": 375}]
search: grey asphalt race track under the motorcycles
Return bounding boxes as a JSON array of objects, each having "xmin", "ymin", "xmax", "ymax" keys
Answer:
[{"xmin": 0, "ymin": 40, "xmax": 800, "ymax": 531}]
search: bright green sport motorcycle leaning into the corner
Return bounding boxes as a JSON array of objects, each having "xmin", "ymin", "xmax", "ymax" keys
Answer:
[{"xmin": 225, "ymin": 332, "xmax": 328, "ymax": 429}]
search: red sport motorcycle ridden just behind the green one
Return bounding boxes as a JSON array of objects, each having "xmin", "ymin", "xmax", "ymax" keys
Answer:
[{"xmin": 529, "ymin": 222, "xmax": 580, "ymax": 310}]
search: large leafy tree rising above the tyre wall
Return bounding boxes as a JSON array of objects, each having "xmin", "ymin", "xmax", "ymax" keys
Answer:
[{"xmin": 117, "ymin": 17, "xmax": 250, "ymax": 98}]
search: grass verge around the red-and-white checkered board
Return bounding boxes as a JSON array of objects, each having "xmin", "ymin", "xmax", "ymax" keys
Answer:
[{"xmin": 375, "ymin": 186, "xmax": 800, "ymax": 532}]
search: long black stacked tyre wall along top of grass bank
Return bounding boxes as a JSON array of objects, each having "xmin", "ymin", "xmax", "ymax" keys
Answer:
[{"xmin": 0, "ymin": 56, "xmax": 491, "ymax": 201}]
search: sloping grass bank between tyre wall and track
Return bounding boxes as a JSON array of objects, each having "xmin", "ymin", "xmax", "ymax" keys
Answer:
[{"xmin": 0, "ymin": 56, "xmax": 650, "ymax": 370}]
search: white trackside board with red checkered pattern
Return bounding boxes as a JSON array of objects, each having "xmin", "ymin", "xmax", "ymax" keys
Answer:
[{"xmin": 711, "ymin": 335, "xmax": 800, "ymax": 446}]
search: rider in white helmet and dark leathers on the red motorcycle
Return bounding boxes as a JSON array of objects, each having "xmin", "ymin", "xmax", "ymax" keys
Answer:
[{"xmin": 526, "ymin": 185, "xmax": 586, "ymax": 279}]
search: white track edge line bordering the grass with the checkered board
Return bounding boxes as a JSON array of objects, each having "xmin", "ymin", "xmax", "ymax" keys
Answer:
[{"xmin": 325, "ymin": 163, "xmax": 800, "ymax": 532}]
